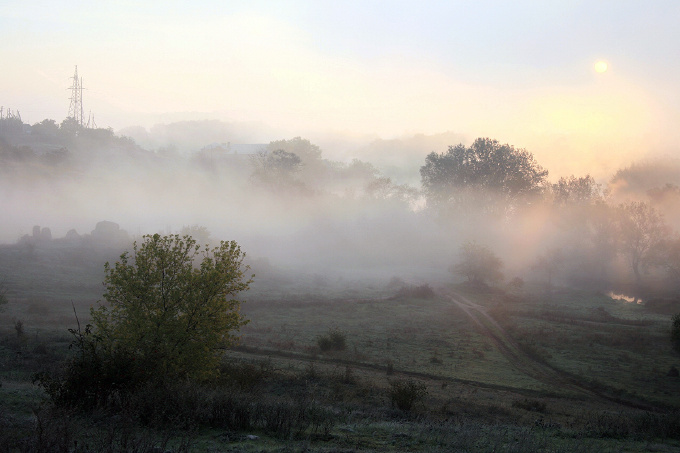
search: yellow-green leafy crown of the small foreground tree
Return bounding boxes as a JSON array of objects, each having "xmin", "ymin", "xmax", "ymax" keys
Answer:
[{"xmin": 92, "ymin": 234, "xmax": 252, "ymax": 379}]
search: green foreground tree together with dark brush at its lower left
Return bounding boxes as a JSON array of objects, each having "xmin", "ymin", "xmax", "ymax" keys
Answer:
[{"xmin": 35, "ymin": 234, "xmax": 250, "ymax": 407}]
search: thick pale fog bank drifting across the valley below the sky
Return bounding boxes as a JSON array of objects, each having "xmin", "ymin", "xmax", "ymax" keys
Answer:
[{"xmin": 0, "ymin": 118, "xmax": 680, "ymax": 292}]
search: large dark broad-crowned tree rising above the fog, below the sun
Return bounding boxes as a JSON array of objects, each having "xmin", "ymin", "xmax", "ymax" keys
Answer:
[{"xmin": 420, "ymin": 138, "xmax": 548, "ymax": 213}]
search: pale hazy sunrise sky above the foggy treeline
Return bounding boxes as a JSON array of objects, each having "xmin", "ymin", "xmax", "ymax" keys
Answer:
[{"xmin": 0, "ymin": 0, "xmax": 680, "ymax": 174}]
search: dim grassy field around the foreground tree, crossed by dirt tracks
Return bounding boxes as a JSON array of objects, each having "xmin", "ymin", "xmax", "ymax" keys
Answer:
[{"xmin": 0, "ymin": 242, "xmax": 680, "ymax": 452}]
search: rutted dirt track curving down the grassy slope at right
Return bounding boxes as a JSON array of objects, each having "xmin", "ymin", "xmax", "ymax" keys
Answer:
[{"xmin": 441, "ymin": 290, "xmax": 654, "ymax": 410}]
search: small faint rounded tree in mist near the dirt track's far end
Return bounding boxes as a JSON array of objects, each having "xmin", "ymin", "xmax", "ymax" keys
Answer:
[{"xmin": 449, "ymin": 242, "xmax": 503, "ymax": 286}]
